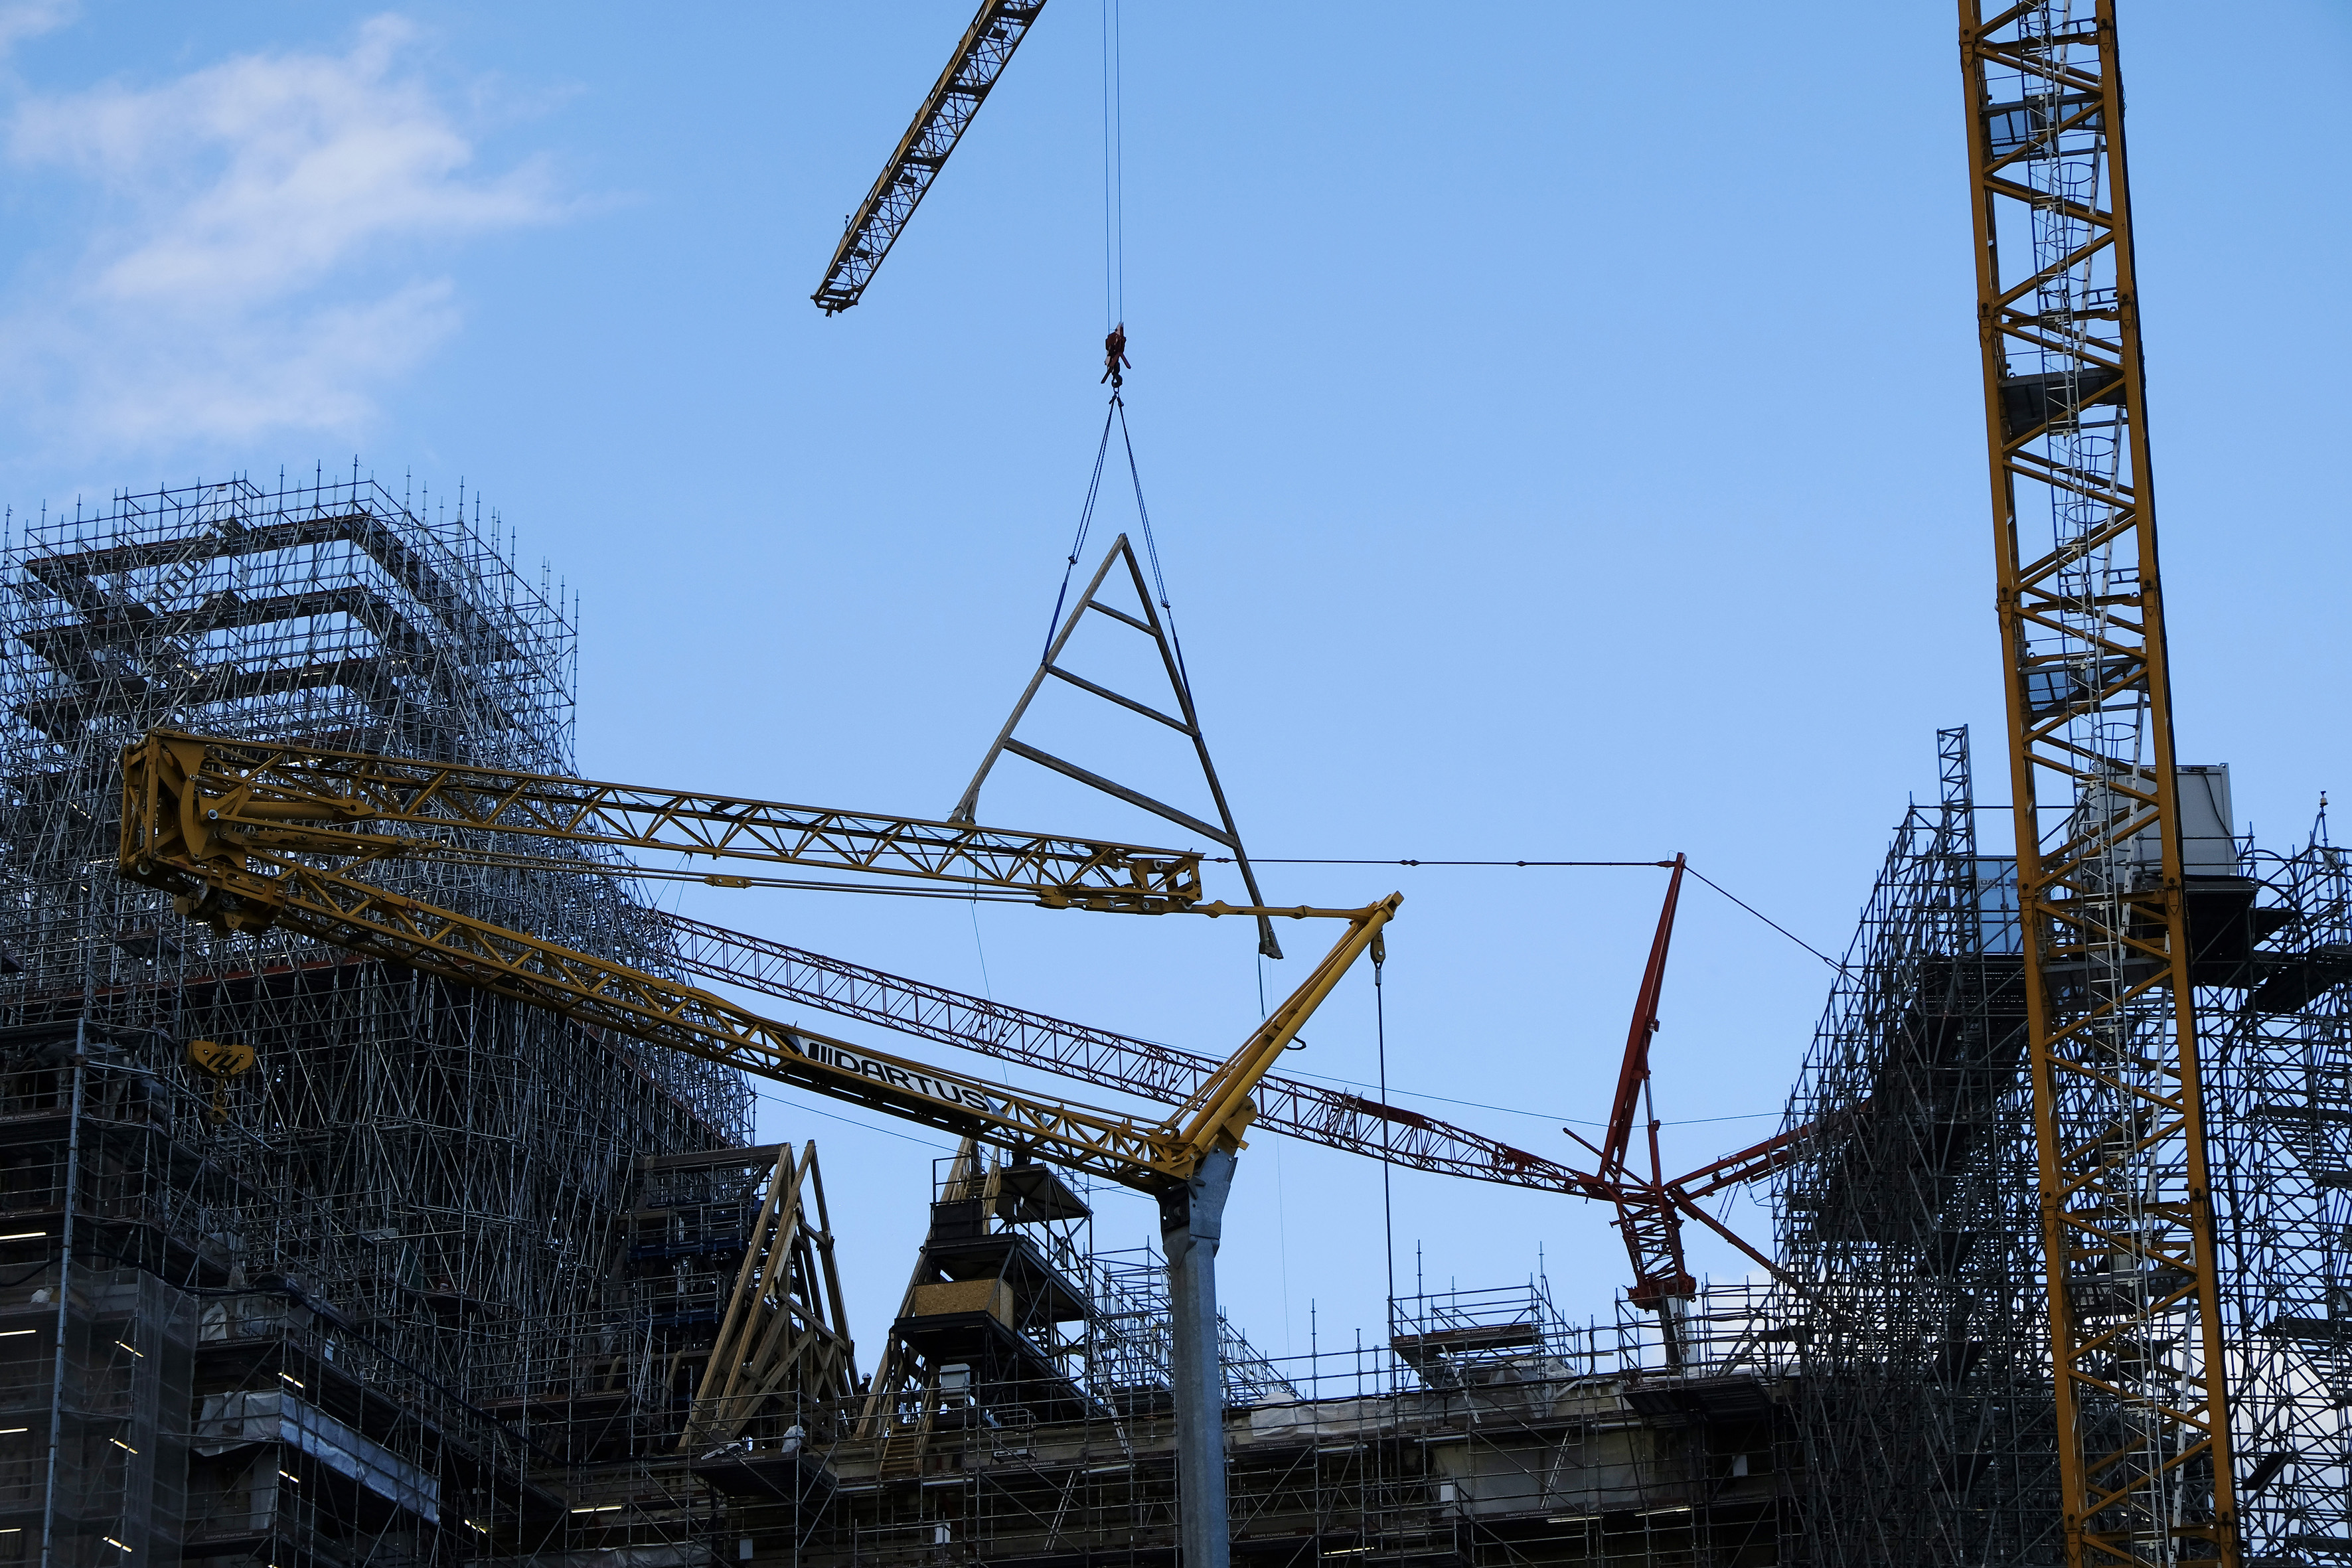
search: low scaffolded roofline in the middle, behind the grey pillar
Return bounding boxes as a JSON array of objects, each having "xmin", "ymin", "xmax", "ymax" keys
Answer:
[{"xmin": 734, "ymin": 1150, "xmax": 1802, "ymax": 1568}]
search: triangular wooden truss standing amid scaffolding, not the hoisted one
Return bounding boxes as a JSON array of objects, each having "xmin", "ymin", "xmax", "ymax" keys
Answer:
[{"xmin": 677, "ymin": 1140, "xmax": 858, "ymax": 1452}]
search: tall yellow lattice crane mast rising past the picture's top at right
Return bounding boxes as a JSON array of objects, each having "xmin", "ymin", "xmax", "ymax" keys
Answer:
[{"xmin": 1959, "ymin": 0, "xmax": 2241, "ymax": 1568}]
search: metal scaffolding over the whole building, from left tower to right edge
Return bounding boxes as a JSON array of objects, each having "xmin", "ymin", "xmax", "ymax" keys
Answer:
[{"xmin": 13, "ymin": 465, "xmax": 2352, "ymax": 1568}]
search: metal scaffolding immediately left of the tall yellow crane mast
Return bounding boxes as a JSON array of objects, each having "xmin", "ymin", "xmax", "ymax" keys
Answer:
[{"xmin": 1773, "ymin": 729, "xmax": 2058, "ymax": 1565}]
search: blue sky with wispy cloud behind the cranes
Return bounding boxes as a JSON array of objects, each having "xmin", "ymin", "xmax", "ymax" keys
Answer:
[{"xmin": 0, "ymin": 0, "xmax": 2352, "ymax": 1361}]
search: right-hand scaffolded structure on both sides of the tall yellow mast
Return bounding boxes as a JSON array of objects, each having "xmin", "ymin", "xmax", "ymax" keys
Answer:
[{"xmin": 1766, "ymin": 729, "xmax": 2352, "ymax": 1568}]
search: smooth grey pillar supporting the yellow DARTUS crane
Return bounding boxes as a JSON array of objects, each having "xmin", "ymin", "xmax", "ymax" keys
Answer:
[{"xmin": 1160, "ymin": 1150, "xmax": 1233, "ymax": 1568}]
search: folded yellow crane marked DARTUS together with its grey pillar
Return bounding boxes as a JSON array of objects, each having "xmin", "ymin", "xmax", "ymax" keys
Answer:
[{"xmin": 118, "ymin": 731, "xmax": 1402, "ymax": 1563}]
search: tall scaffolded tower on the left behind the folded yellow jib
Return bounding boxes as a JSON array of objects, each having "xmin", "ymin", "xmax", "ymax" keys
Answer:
[{"xmin": 0, "ymin": 475, "xmax": 750, "ymax": 1568}]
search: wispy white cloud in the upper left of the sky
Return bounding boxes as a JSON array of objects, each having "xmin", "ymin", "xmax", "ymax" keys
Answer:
[{"xmin": 0, "ymin": 17, "xmax": 564, "ymax": 447}]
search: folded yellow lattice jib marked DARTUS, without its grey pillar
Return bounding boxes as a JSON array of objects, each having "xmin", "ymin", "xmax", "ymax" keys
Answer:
[{"xmin": 118, "ymin": 731, "xmax": 1399, "ymax": 1192}]
